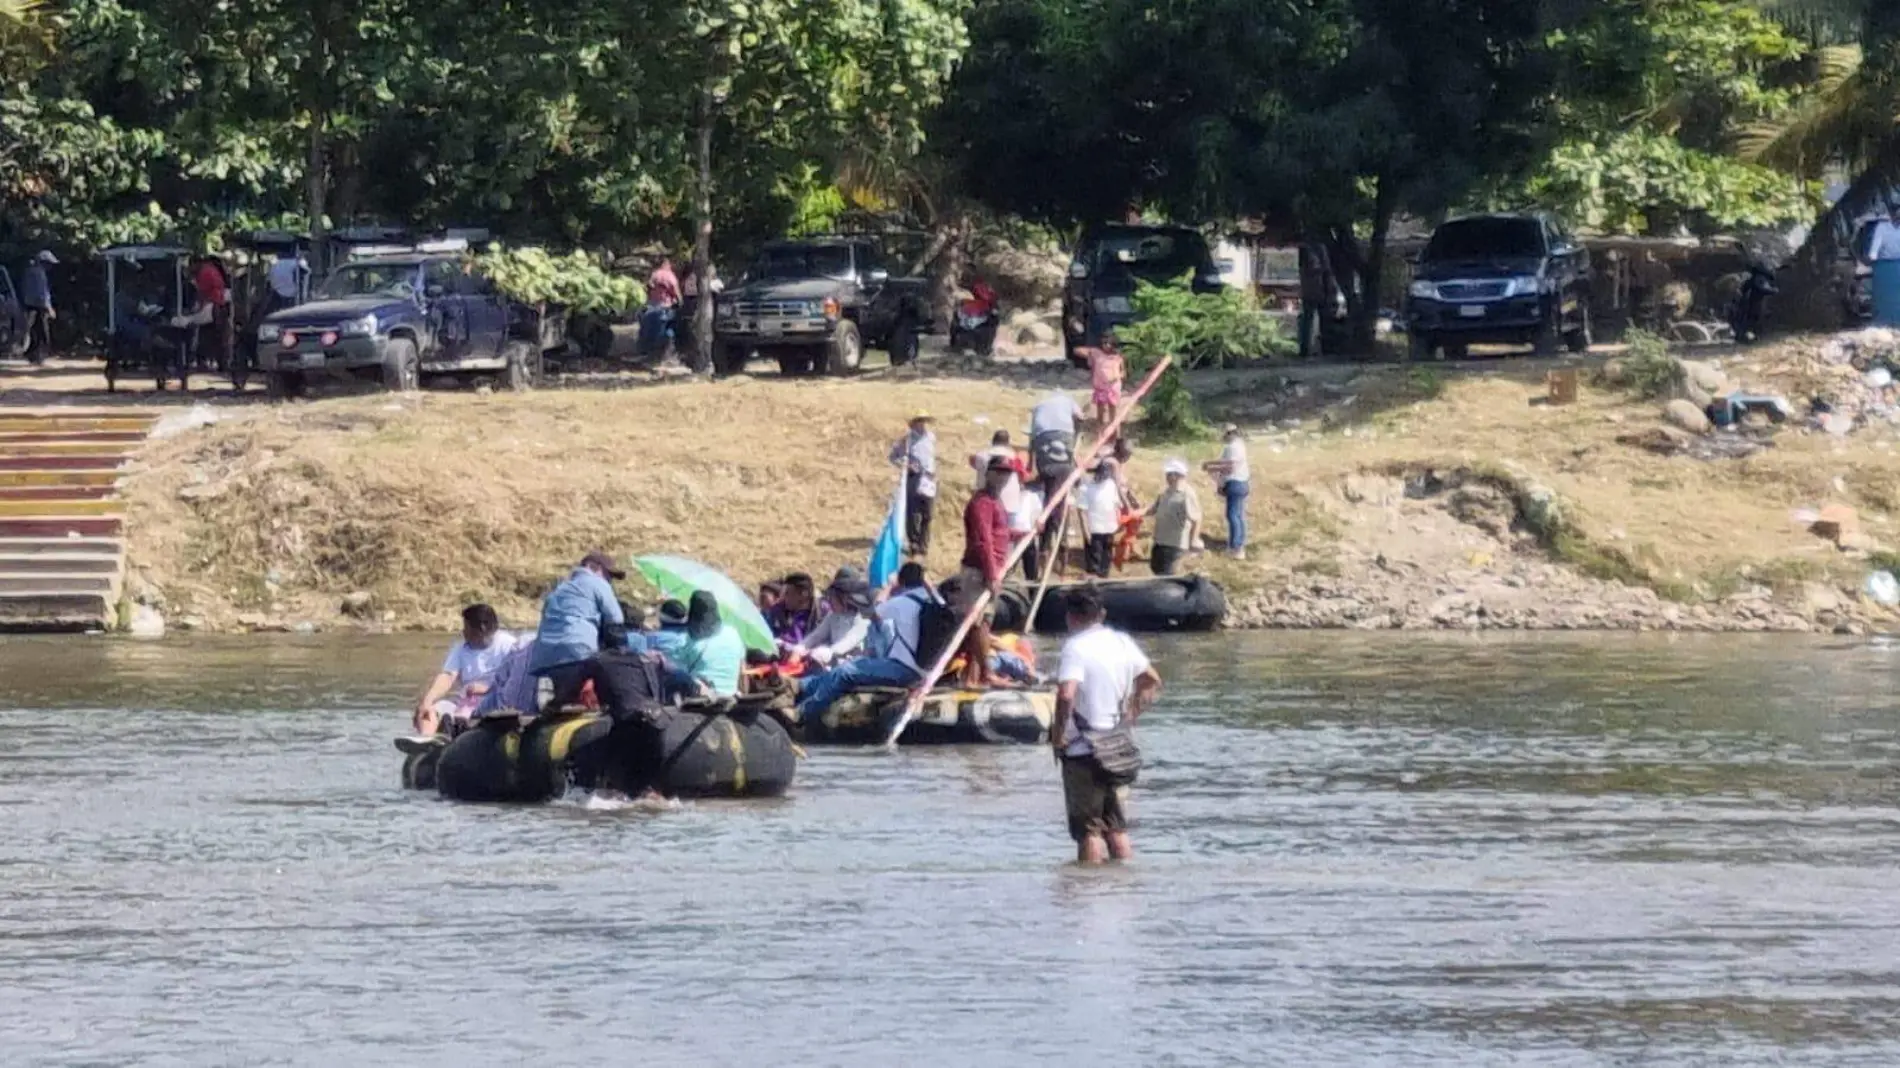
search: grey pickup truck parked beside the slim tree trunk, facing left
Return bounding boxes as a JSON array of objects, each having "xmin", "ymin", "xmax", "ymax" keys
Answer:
[{"xmin": 713, "ymin": 238, "xmax": 931, "ymax": 374}]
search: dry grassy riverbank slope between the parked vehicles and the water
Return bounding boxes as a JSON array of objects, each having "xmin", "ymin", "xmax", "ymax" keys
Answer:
[{"xmin": 114, "ymin": 336, "xmax": 1900, "ymax": 629}]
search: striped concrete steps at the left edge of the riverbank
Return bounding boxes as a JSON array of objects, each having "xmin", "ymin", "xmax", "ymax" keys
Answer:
[{"xmin": 0, "ymin": 409, "xmax": 156, "ymax": 631}]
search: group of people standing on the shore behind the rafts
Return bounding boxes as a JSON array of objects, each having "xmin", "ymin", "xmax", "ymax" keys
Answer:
[{"xmin": 889, "ymin": 382, "xmax": 1252, "ymax": 583}]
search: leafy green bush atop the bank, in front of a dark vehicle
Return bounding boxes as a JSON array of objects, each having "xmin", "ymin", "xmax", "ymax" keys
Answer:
[{"xmin": 1115, "ymin": 281, "xmax": 1294, "ymax": 441}]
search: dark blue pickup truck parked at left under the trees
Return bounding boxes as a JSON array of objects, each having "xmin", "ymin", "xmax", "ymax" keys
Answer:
[{"xmin": 257, "ymin": 251, "xmax": 564, "ymax": 397}]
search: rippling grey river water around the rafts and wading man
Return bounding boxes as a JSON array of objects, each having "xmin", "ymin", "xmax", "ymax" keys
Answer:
[{"xmin": 0, "ymin": 635, "xmax": 1900, "ymax": 1066}]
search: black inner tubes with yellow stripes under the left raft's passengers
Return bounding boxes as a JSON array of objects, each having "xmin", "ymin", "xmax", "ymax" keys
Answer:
[{"xmin": 403, "ymin": 709, "xmax": 798, "ymax": 802}]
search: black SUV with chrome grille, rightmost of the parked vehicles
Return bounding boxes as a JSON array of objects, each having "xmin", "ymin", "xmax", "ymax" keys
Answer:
[{"xmin": 1406, "ymin": 213, "xmax": 1590, "ymax": 359}]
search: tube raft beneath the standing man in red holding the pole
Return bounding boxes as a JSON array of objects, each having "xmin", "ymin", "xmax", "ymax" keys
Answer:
[{"xmin": 800, "ymin": 688, "xmax": 1056, "ymax": 745}]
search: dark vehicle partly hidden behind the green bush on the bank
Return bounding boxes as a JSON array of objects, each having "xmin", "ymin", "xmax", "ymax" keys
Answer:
[{"xmin": 1062, "ymin": 224, "xmax": 1222, "ymax": 367}]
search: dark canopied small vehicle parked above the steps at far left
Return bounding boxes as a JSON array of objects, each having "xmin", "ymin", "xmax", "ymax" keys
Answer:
[{"xmin": 103, "ymin": 245, "xmax": 198, "ymax": 391}]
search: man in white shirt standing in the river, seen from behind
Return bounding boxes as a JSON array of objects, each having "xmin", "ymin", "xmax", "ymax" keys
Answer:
[{"xmin": 1049, "ymin": 585, "xmax": 1161, "ymax": 865}]
